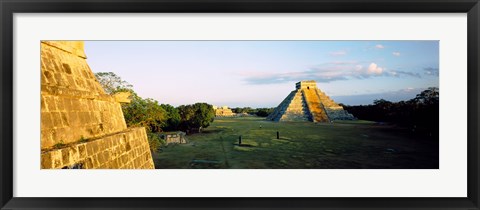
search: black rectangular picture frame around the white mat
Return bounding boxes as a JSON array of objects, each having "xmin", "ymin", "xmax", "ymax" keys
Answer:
[{"xmin": 0, "ymin": 0, "xmax": 480, "ymax": 209}]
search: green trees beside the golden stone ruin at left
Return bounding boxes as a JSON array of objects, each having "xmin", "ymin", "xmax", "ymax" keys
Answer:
[{"xmin": 95, "ymin": 72, "xmax": 215, "ymax": 151}]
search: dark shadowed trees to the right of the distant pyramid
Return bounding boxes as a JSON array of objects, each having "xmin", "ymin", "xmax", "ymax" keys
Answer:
[{"xmin": 342, "ymin": 87, "xmax": 440, "ymax": 140}]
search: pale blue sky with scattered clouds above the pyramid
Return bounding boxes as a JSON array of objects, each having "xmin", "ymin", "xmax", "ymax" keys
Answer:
[{"xmin": 85, "ymin": 41, "xmax": 439, "ymax": 108}]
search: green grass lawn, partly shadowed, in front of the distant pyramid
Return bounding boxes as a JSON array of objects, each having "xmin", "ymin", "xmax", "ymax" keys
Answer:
[{"xmin": 153, "ymin": 117, "xmax": 439, "ymax": 169}]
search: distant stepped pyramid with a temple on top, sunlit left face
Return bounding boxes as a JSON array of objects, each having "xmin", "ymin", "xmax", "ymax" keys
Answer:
[{"xmin": 267, "ymin": 80, "xmax": 355, "ymax": 122}]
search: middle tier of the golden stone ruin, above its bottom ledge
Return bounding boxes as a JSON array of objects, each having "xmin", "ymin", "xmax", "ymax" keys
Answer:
[{"xmin": 41, "ymin": 95, "xmax": 127, "ymax": 149}]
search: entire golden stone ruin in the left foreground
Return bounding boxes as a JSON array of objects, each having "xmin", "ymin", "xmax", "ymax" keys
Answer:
[{"xmin": 41, "ymin": 41, "xmax": 154, "ymax": 169}]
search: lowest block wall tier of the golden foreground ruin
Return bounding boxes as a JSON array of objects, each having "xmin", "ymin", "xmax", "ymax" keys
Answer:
[{"xmin": 41, "ymin": 128, "xmax": 154, "ymax": 169}]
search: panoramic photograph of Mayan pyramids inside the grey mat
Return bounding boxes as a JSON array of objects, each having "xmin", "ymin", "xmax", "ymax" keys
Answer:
[{"xmin": 39, "ymin": 40, "xmax": 440, "ymax": 169}]
